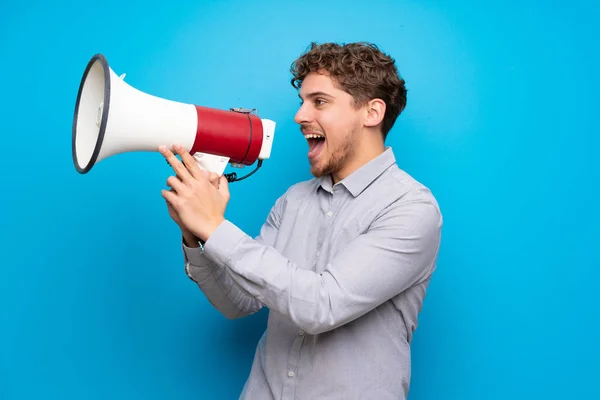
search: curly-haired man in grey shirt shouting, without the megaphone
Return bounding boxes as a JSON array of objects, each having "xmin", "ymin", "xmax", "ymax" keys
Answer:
[{"xmin": 159, "ymin": 43, "xmax": 442, "ymax": 400}]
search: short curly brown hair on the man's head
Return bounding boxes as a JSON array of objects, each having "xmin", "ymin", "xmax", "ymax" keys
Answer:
[{"xmin": 290, "ymin": 42, "xmax": 406, "ymax": 139}]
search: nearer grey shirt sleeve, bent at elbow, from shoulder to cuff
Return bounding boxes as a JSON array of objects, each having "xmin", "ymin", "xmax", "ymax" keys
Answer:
[{"xmin": 205, "ymin": 200, "xmax": 442, "ymax": 334}]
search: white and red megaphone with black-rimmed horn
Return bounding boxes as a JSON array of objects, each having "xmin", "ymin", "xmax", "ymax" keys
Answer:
[{"xmin": 72, "ymin": 54, "xmax": 275, "ymax": 182}]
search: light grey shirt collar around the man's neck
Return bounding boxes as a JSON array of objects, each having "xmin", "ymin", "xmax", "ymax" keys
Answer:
[{"xmin": 317, "ymin": 146, "xmax": 396, "ymax": 197}]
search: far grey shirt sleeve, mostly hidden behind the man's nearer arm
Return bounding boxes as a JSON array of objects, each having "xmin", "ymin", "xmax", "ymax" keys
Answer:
[{"xmin": 182, "ymin": 191, "xmax": 285, "ymax": 319}]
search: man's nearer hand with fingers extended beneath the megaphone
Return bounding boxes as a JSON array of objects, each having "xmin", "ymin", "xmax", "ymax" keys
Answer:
[{"xmin": 158, "ymin": 145, "xmax": 230, "ymax": 241}]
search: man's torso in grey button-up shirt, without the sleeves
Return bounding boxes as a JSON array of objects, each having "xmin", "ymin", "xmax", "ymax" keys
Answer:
[{"xmin": 242, "ymin": 148, "xmax": 437, "ymax": 400}]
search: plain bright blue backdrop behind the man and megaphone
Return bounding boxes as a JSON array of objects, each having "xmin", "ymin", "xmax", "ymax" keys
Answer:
[{"xmin": 0, "ymin": 0, "xmax": 600, "ymax": 400}]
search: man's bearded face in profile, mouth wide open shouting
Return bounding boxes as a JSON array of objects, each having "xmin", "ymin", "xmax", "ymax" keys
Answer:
[{"xmin": 294, "ymin": 73, "xmax": 365, "ymax": 178}]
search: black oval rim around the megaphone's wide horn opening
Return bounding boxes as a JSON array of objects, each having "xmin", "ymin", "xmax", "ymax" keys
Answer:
[{"xmin": 71, "ymin": 54, "xmax": 110, "ymax": 174}]
